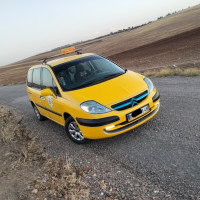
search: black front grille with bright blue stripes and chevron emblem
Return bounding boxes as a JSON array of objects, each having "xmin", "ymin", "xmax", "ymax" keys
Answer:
[{"xmin": 111, "ymin": 90, "xmax": 149, "ymax": 111}]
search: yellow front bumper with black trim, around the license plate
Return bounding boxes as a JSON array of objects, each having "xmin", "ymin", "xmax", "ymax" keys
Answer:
[{"xmin": 76, "ymin": 89, "xmax": 160, "ymax": 139}]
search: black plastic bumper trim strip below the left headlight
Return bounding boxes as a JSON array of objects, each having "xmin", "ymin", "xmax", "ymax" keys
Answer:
[{"xmin": 76, "ymin": 116, "xmax": 119, "ymax": 127}]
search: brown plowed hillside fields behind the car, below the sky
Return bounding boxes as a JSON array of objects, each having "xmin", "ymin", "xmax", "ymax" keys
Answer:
[{"xmin": 0, "ymin": 5, "xmax": 200, "ymax": 85}]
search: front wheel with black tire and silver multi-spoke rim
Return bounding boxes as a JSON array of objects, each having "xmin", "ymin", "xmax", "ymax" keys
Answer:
[{"xmin": 65, "ymin": 116, "xmax": 87, "ymax": 144}]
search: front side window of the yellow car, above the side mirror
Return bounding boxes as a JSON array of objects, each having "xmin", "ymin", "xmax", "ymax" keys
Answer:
[{"xmin": 42, "ymin": 68, "xmax": 59, "ymax": 95}]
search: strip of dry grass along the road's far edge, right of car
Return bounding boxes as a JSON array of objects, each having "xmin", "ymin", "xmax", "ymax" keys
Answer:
[{"xmin": 143, "ymin": 67, "xmax": 200, "ymax": 77}]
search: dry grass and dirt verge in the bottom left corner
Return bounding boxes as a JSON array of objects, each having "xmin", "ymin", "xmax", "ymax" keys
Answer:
[{"xmin": 0, "ymin": 106, "xmax": 90, "ymax": 200}]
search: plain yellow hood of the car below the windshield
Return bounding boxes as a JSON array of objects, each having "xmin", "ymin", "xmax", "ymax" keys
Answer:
[{"xmin": 63, "ymin": 71, "xmax": 147, "ymax": 105}]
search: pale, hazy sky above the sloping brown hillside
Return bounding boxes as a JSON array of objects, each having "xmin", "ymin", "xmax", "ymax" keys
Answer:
[{"xmin": 0, "ymin": 0, "xmax": 200, "ymax": 66}]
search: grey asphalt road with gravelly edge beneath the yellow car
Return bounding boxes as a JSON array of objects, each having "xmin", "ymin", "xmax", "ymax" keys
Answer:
[{"xmin": 0, "ymin": 77, "xmax": 200, "ymax": 199}]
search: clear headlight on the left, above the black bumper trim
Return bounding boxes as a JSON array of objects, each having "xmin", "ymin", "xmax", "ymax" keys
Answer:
[{"xmin": 80, "ymin": 101, "xmax": 111, "ymax": 114}]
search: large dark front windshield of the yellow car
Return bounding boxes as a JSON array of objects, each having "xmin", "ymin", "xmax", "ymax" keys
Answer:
[{"xmin": 52, "ymin": 55, "xmax": 125, "ymax": 91}]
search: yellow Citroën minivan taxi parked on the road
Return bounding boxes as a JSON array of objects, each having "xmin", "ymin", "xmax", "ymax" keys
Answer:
[{"xmin": 27, "ymin": 51, "xmax": 160, "ymax": 144}]
